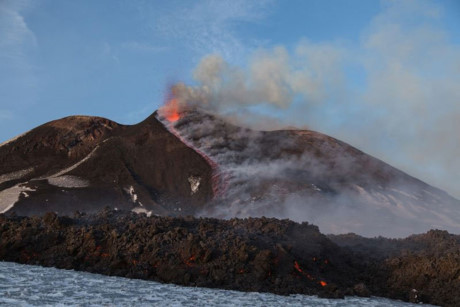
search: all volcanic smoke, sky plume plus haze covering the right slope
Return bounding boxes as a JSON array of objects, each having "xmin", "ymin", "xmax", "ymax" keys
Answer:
[{"xmin": 155, "ymin": 1, "xmax": 460, "ymax": 237}]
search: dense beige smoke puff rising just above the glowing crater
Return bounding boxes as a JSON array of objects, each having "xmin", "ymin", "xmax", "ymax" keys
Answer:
[{"xmin": 173, "ymin": 43, "xmax": 340, "ymax": 112}]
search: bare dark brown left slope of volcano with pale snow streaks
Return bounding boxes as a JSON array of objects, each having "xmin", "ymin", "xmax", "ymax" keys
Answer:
[{"xmin": 0, "ymin": 115, "xmax": 212, "ymax": 215}]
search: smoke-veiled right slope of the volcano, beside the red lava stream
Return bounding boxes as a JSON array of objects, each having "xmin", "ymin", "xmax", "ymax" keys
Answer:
[{"xmin": 160, "ymin": 111, "xmax": 460, "ymax": 237}]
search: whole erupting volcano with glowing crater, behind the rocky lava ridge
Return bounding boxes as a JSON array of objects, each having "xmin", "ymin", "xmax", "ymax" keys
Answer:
[{"xmin": 0, "ymin": 109, "xmax": 460, "ymax": 237}]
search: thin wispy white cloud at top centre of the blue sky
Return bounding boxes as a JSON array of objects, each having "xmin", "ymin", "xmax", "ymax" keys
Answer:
[{"xmin": 154, "ymin": 0, "xmax": 273, "ymax": 60}]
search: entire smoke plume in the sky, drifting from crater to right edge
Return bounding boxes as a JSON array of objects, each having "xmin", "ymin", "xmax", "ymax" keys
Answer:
[{"xmin": 164, "ymin": 2, "xmax": 460, "ymax": 197}]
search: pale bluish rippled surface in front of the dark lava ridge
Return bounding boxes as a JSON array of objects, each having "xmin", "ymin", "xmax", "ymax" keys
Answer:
[{"xmin": 0, "ymin": 262, "xmax": 434, "ymax": 307}]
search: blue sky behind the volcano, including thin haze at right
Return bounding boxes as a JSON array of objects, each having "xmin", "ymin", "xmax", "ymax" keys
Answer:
[{"xmin": 0, "ymin": 0, "xmax": 460, "ymax": 197}]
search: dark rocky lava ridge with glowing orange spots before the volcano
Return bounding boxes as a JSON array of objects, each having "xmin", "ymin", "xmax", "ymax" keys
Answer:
[{"xmin": 0, "ymin": 209, "xmax": 460, "ymax": 306}]
